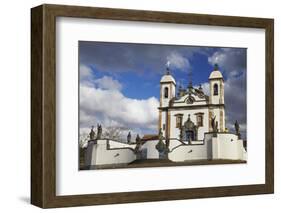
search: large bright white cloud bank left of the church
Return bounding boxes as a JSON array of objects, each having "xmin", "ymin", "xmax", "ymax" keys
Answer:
[{"xmin": 80, "ymin": 85, "xmax": 159, "ymax": 133}]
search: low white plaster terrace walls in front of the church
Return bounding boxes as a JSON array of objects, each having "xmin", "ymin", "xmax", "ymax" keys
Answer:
[{"xmin": 85, "ymin": 133, "xmax": 247, "ymax": 166}]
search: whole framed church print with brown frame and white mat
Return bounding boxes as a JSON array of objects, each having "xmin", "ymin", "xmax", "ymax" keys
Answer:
[{"xmin": 31, "ymin": 5, "xmax": 274, "ymax": 208}]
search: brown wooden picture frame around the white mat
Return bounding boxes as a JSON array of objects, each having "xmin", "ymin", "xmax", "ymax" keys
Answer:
[{"xmin": 31, "ymin": 5, "xmax": 274, "ymax": 208}]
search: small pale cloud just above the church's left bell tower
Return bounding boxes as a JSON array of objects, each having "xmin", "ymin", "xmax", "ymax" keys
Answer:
[{"xmin": 167, "ymin": 51, "xmax": 191, "ymax": 71}]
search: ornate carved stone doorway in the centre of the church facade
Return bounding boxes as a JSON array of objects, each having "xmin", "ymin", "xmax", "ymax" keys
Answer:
[{"xmin": 181, "ymin": 114, "xmax": 198, "ymax": 142}]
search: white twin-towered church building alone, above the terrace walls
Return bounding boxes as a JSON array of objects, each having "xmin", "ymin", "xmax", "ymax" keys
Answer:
[{"xmin": 158, "ymin": 65, "xmax": 226, "ymax": 141}]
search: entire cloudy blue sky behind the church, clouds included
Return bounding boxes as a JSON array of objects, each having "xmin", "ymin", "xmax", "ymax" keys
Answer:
[{"xmin": 79, "ymin": 41, "xmax": 246, "ymax": 139}]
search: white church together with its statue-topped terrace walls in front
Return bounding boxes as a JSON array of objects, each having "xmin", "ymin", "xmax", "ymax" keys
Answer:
[{"xmin": 85, "ymin": 66, "xmax": 247, "ymax": 169}]
